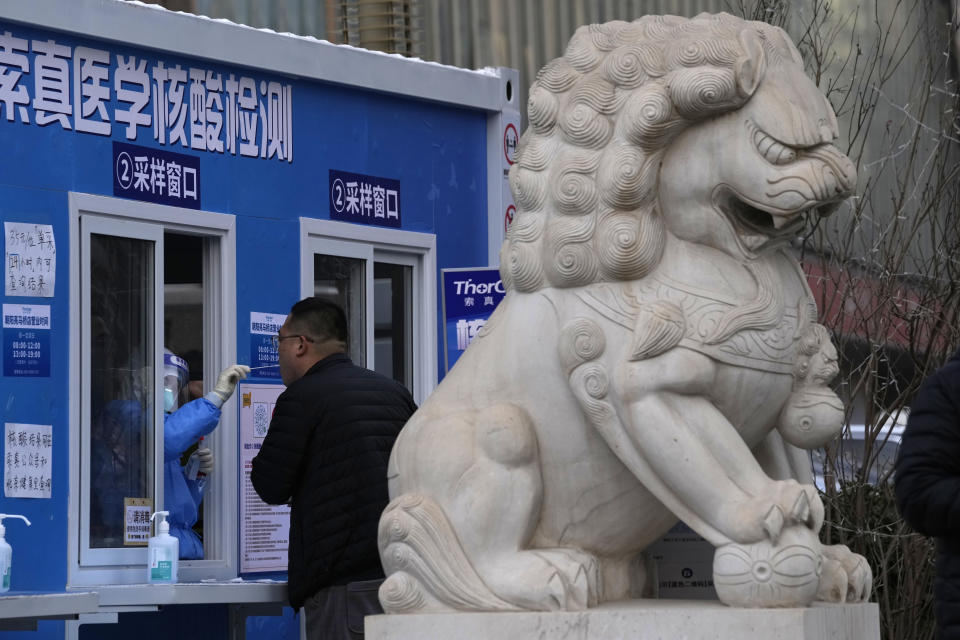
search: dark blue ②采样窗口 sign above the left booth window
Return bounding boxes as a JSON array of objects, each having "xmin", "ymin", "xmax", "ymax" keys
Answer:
[{"xmin": 113, "ymin": 142, "xmax": 200, "ymax": 209}]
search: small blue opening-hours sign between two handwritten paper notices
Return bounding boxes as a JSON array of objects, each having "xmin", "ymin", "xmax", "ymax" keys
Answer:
[{"xmin": 3, "ymin": 304, "xmax": 50, "ymax": 378}]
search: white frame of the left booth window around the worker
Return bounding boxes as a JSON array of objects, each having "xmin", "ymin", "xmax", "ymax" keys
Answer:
[{"xmin": 67, "ymin": 192, "xmax": 238, "ymax": 587}]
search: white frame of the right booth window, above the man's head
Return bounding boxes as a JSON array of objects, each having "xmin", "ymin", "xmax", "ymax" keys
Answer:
[{"xmin": 300, "ymin": 218, "xmax": 437, "ymax": 404}]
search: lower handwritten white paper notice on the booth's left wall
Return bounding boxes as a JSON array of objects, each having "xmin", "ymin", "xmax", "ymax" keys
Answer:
[{"xmin": 3, "ymin": 422, "xmax": 53, "ymax": 498}]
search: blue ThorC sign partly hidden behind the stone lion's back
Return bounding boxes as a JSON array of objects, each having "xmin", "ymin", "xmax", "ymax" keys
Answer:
[{"xmin": 441, "ymin": 267, "xmax": 506, "ymax": 371}]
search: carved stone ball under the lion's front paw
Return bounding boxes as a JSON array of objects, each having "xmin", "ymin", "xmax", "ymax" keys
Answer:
[{"xmin": 713, "ymin": 526, "xmax": 822, "ymax": 607}]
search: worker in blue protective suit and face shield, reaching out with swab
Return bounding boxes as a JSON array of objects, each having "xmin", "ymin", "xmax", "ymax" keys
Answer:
[{"xmin": 163, "ymin": 350, "xmax": 250, "ymax": 560}]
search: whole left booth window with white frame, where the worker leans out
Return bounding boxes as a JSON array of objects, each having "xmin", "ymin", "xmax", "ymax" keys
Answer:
[{"xmin": 71, "ymin": 195, "xmax": 236, "ymax": 584}]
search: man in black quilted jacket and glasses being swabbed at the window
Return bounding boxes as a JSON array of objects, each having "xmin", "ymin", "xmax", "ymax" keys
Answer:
[{"xmin": 250, "ymin": 298, "xmax": 416, "ymax": 639}]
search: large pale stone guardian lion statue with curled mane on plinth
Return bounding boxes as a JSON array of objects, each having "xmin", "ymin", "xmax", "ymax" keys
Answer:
[{"xmin": 379, "ymin": 14, "xmax": 871, "ymax": 613}]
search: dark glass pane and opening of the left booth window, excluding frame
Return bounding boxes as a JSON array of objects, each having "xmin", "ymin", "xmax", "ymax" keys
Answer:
[{"xmin": 90, "ymin": 233, "xmax": 203, "ymax": 549}]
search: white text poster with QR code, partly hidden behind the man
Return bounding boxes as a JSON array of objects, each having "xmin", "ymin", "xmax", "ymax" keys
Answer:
[{"xmin": 237, "ymin": 383, "xmax": 290, "ymax": 573}]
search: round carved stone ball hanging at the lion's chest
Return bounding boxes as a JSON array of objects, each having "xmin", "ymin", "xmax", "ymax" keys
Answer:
[{"xmin": 777, "ymin": 387, "xmax": 843, "ymax": 450}]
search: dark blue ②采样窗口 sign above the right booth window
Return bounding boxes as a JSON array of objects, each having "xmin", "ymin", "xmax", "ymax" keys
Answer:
[{"xmin": 330, "ymin": 169, "xmax": 400, "ymax": 229}]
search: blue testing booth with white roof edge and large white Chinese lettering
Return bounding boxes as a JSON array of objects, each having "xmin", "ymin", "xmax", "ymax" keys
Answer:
[{"xmin": 0, "ymin": 0, "xmax": 519, "ymax": 640}]
